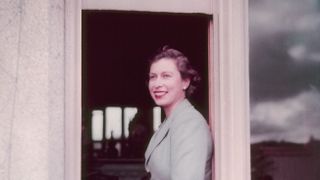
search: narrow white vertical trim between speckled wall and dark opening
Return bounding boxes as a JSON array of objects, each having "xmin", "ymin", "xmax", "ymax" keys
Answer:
[{"xmin": 64, "ymin": 0, "xmax": 82, "ymax": 180}]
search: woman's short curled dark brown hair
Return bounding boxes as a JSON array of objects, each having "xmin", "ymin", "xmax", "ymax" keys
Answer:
[{"xmin": 149, "ymin": 46, "xmax": 201, "ymax": 97}]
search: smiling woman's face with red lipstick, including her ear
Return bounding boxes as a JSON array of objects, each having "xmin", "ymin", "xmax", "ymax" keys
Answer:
[{"xmin": 149, "ymin": 58, "xmax": 190, "ymax": 111}]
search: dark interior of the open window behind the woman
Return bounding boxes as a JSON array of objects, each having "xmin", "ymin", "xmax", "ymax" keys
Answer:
[{"xmin": 82, "ymin": 10, "xmax": 210, "ymax": 180}]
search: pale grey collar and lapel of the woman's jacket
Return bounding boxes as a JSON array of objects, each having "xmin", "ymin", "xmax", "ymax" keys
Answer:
[{"xmin": 145, "ymin": 99, "xmax": 192, "ymax": 166}]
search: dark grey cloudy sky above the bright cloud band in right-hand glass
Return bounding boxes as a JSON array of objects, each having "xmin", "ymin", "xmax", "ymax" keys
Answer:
[{"xmin": 249, "ymin": 0, "xmax": 320, "ymax": 103}]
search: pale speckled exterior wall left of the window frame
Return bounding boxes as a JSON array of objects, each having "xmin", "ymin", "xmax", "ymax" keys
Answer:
[{"xmin": 0, "ymin": 0, "xmax": 64, "ymax": 180}]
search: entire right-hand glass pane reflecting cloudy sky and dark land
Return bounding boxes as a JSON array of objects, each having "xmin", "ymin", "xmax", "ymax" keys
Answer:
[{"xmin": 249, "ymin": 0, "xmax": 320, "ymax": 180}]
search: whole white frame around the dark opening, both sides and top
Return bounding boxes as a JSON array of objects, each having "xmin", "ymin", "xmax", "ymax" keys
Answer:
[{"xmin": 65, "ymin": 0, "xmax": 250, "ymax": 180}]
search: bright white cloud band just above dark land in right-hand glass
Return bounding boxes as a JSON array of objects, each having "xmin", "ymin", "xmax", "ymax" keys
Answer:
[{"xmin": 251, "ymin": 88, "xmax": 320, "ymax": 143}]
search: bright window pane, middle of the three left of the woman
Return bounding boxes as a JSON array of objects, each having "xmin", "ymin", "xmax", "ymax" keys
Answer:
[{"xmin": 105, "ymin": 107, "xmax": 122, "ymax": 139}]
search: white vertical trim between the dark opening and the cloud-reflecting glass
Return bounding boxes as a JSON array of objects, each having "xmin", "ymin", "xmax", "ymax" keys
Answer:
[{"xmin": 213, "ymin": 0, "xmax": 250, "ymax": 180}]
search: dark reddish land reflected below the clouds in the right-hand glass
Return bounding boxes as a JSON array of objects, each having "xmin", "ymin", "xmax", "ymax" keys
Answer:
[{"xmin": 251, "ymin": 137, "xmax": 320, "ymax": 180}]
